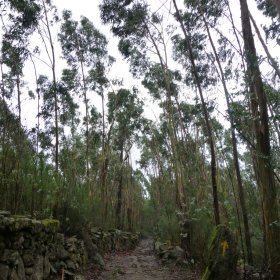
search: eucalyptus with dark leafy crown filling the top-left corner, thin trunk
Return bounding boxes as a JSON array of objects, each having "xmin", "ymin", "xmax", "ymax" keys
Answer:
[{"xmin": 0, "ymin": 1, "xmax": 41, "ymax": 124}]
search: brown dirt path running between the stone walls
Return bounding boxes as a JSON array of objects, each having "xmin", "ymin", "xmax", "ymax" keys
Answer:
[{"xmin": 95, "ymin": 239, "xmax": 199, "ymax": 280}]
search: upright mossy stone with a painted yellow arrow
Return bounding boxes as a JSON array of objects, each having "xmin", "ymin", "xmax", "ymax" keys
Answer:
[{"xmin": 202, "ymin": 225, "xmax": 238, "ymax": 280}]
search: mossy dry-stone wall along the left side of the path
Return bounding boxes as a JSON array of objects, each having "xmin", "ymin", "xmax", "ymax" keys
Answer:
[{"xmin": 0, "ymin": 211, "xmax": 139, "ymax": 280}]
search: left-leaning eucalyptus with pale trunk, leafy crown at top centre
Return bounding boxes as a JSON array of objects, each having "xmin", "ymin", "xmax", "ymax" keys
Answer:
[{"xmin": 100, "ymin": 0, "xmax": 186, "ymax": 210}]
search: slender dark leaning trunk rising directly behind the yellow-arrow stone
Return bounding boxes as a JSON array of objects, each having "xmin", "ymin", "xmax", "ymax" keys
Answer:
[{"xmin": 173, "ymin": 0, "xmax": 220, "ymax": 225}]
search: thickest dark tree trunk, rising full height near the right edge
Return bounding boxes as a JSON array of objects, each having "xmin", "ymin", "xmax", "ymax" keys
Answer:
[{"xmin": 240, "ymin": 0, "xmax": 280, "ymax": 274}]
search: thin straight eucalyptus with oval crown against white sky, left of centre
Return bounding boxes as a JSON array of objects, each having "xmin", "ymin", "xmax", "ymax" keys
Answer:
[{"xmin": 59, "ymin": 11, "xmax": 112, "ymax": 180}]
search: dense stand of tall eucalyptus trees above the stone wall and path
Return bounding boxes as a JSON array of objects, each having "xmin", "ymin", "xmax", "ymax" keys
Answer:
[{"xmin": 0, "ymin": 0, "xmax": 280, "ymax": 274}]
